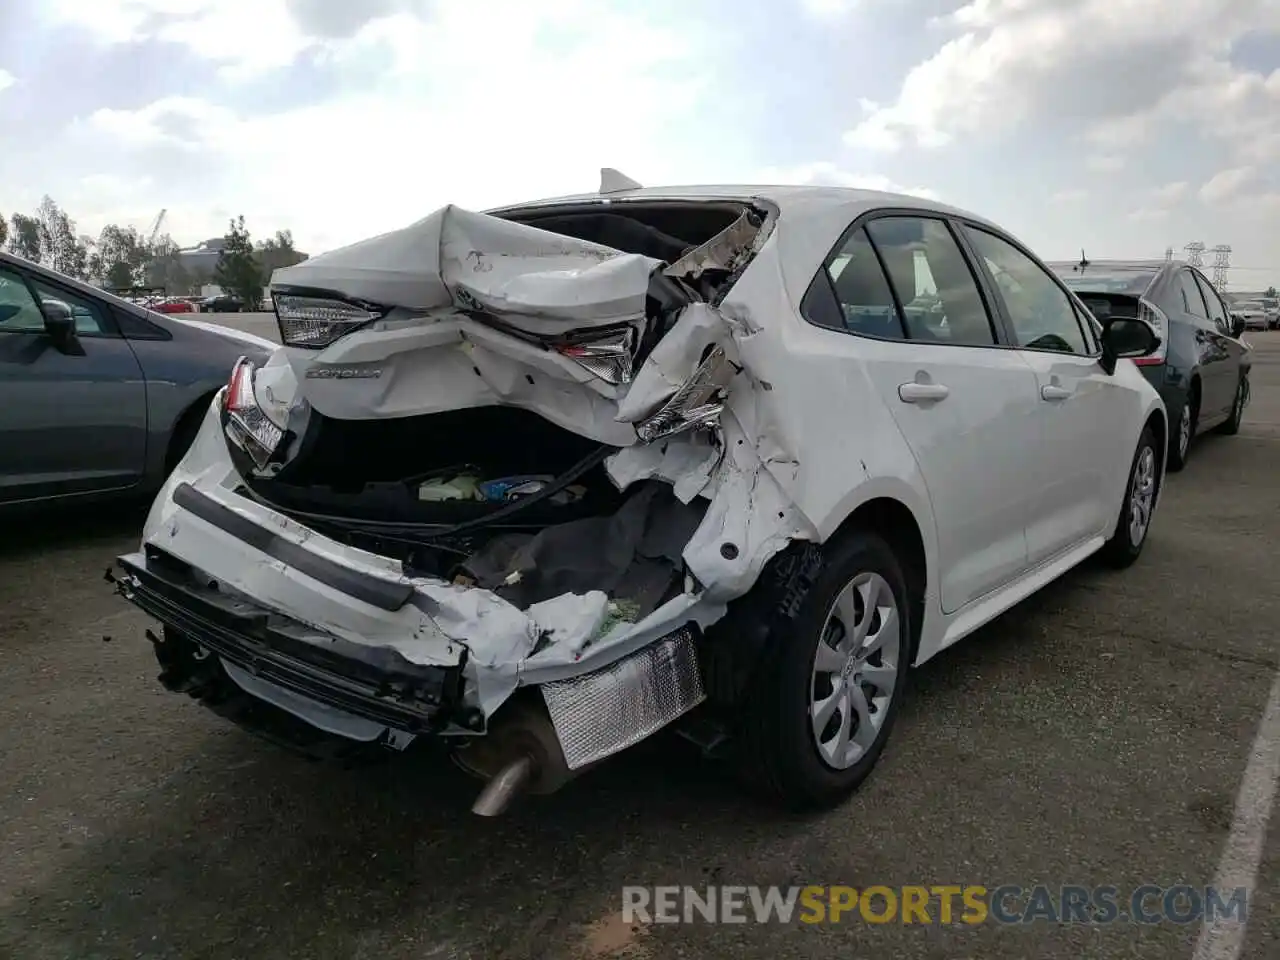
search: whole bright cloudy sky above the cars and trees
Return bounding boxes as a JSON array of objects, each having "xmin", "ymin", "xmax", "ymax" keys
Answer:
[{"xmin": 0, "ymin": 0, "xmax": 1280, "ymax": 288}]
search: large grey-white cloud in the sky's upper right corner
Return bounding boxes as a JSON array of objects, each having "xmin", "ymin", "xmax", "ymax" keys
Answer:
[{"xmin": 846, "ymin": 0, "xmax": 1280, "ymax": 160}]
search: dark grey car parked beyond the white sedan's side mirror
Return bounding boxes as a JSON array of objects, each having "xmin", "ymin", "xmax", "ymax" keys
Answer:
[{"xmin": 1051, "ymin": 260, "xmax": 1253, "ymax": 470}]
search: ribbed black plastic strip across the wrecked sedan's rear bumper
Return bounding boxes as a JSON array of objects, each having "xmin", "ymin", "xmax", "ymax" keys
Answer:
[{"xmin": 109, "ymin": 547, "xmax": 462, "ymax": 733}]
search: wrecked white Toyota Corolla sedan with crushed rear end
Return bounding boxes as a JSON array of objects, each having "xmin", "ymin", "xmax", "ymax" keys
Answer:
[{"xmin": 114, "ymin": 170, "xmax": 1167, "ymax": 814}]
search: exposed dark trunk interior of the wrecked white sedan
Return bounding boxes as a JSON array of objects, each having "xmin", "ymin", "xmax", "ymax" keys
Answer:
[{"xmin": 242, "ymin": 407, "xmax": 707, "ymax": 618}]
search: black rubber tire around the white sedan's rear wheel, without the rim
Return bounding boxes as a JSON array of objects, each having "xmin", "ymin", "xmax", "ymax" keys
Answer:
[{"xmin": 739, "ymin": 532, "xmax": 915, "ymax": 812}]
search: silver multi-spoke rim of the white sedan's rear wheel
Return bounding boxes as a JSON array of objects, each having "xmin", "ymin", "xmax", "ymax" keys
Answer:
[{"xmin": 809, "ymin": 572, "xmax": 904, "ymax": 771}]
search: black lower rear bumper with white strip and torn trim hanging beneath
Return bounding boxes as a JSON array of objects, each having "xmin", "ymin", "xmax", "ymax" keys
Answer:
[{"xmin": 108, "ymin": 547, "xmax": 471, "ymax": 748}]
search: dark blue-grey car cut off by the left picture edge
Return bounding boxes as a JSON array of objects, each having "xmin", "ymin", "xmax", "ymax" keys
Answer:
[{"xmin": 0, "ymin": 253, "xmax": 274, "ymax": 512}]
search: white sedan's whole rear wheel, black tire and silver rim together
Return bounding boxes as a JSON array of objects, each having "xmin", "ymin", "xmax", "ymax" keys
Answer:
[{"xmin": 740, "ymin": 532, "xmax": 913, "ymax": 810}]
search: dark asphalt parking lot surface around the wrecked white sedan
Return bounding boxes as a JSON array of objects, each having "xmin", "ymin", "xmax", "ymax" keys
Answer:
[{"xmin": 0, "ymin": 327, "xmax": 1280, "ymax": 960}]
